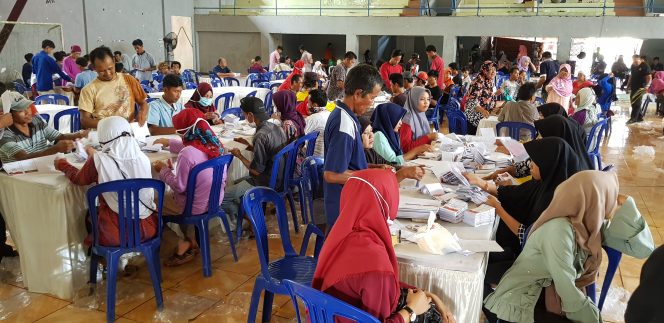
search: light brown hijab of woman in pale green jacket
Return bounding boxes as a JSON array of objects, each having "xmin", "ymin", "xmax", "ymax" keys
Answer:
[{"xmin": 530, "ymin": 170, "xmax": 619, "ymax": 287}]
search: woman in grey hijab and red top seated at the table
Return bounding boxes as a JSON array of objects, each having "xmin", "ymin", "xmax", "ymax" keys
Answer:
[{"xmin": 399, "ymin": 86, "xmax": 438, "ymax": 152}]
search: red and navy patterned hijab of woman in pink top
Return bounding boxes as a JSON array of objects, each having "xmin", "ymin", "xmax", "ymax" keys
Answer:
[{"xmin": 173, "ymin": 108, "xmax": 224, "ymax": 159}]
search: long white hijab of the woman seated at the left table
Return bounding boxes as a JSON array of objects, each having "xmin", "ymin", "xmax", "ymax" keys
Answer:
[{"xmin": 94, "ymin": 116, "xmax": 157, "ymax": 219}]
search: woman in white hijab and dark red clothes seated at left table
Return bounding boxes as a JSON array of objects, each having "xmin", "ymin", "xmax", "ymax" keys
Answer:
[{"xmin": 54, "ymin": 116, "xmax": 160, "ymax": 247}]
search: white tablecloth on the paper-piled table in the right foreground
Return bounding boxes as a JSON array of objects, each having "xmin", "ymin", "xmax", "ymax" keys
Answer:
[{"xmin": 394, "ymin": 168, "xmax": 498, "ymax": 323}]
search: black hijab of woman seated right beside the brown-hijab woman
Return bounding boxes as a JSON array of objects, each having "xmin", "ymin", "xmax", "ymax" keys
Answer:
[{"xmin": 496, "ymin": 137, "xmax": 585, "ymax": 250}]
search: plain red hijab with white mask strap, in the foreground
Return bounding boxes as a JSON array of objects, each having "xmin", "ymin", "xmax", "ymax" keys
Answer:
[{"xmin": 312, "ymin": 169, "xmax": 399, "ymax": 308}]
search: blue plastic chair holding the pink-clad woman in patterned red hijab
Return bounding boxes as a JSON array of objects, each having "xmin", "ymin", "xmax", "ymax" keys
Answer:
[{"xmin": 164, "ymin": 154, "xmax": 237, "ymax": 277}]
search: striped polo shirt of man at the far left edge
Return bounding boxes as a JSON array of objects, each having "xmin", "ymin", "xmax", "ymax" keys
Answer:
[{"xmin": 0, "ymin": 117, "xmax": 60, "ymax": 164}]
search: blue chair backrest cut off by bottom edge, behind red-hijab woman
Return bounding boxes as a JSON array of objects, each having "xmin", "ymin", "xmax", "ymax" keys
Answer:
[{"xmin": 283, "ymin": 279, "xmax": 380, "ymax": 323}]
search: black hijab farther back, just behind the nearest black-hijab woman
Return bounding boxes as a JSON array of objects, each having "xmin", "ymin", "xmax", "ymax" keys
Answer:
[{"xmin": 535, "ymin": 115, "xmax": 593, "ymax": 170}]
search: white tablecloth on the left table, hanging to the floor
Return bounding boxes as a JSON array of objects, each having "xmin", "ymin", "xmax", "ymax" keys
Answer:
[{"xmin": 0, "ymin": 126, "xmax": 253, "ymax": 299}]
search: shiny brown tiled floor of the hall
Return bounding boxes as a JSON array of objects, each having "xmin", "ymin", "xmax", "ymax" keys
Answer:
[{"xmin": 0, "ymin": 97, "xmax": 664, "ymax": 322}]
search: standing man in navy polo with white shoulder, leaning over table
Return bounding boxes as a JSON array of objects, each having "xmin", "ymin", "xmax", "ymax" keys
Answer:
[{"xmin": 323, "ymin": 64, "xmax": 424, "ymax": 232}]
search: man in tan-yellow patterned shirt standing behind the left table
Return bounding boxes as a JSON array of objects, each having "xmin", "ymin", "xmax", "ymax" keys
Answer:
[{"xmin": 78, "ymin": 46, "xmax": 149, "ymax": 129}]
